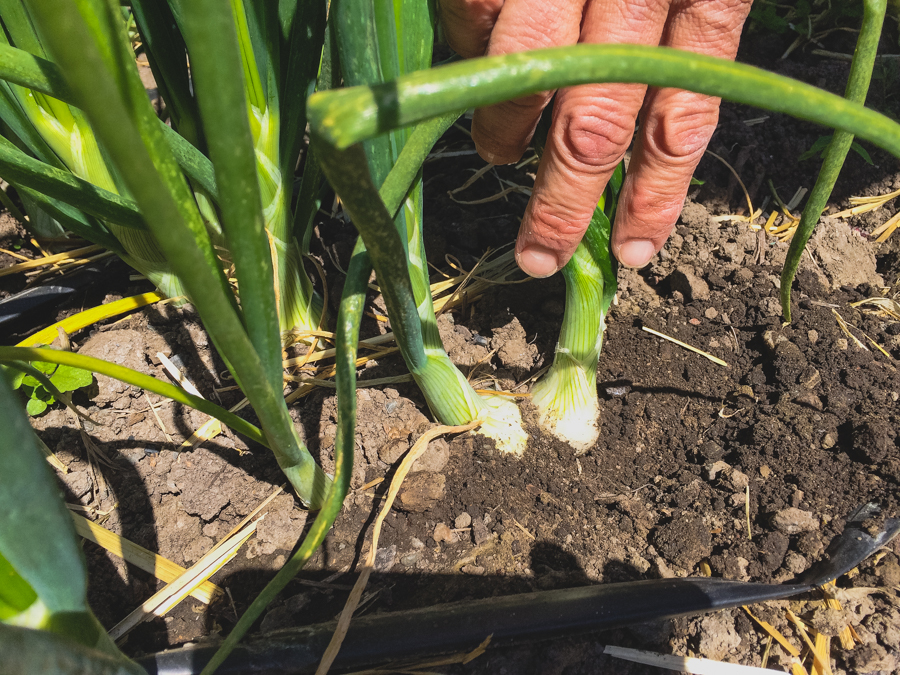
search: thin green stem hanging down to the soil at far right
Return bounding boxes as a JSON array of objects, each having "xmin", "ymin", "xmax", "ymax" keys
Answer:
[{"xmin": 781, "ymin": 0, "xmax": 887, "ymax": 323}]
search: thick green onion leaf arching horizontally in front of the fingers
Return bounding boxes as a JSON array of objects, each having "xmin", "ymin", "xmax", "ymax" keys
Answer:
[{"xmin": 307, "ymin": 44, "xmax": 900, "ymax": 157}]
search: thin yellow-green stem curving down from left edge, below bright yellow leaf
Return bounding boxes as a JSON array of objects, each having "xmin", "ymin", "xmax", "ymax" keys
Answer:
[{"xmin": 0, "ymin": 347, "xmax": 269, "ymax": 447}]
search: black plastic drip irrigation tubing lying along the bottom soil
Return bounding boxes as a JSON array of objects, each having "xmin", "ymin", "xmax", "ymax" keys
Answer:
[{"xmin": 138, "ymin": 504, "xmax": 900, "ymax": 675}]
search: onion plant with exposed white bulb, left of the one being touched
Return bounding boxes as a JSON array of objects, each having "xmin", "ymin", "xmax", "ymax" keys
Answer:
[{"xmin": 322, "ymin": 0, "xmax": 527, "ymax": 454}]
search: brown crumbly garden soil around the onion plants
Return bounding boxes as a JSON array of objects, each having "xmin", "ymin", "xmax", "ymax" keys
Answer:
[{"xmin": 7, "ymin": 29, "xmax": 900, "ymax": 675}]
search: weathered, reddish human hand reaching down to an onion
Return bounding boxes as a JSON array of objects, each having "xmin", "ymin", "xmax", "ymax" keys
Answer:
[{"xmin": 440, "ymin": 0, "xmax": 751, "ymax": 277}]
